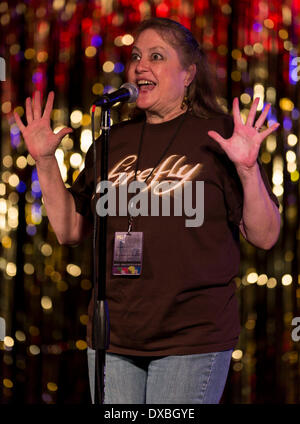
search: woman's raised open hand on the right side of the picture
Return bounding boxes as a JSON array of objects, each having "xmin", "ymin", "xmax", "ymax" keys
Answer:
[{"xmin": 208, "ymin": 97, "xmax": 280, "ymax": 171}]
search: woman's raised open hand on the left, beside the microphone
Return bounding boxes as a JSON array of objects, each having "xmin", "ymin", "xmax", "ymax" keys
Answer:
[{"xmin": 14, "ymin": 91, "xmax": 73, "ymax": 161}]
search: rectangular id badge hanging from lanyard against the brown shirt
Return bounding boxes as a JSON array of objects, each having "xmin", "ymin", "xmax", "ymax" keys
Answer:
[{"xmin": 112, "ymin": 232, "xmax": 143, "ymax": 275}]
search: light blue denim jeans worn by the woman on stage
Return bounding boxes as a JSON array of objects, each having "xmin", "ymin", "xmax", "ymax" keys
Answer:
[{"xmin": 88, "ymin": 348, "xmax": 232, "ymax": 404}]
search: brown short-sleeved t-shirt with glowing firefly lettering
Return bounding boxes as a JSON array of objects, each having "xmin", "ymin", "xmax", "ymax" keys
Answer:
[{"xmin": 70, "ymin": 113, "xmax": 278, "ymax": 356}]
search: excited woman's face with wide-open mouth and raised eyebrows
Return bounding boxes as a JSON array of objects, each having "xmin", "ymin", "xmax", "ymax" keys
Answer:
[{"xmin": 127, "ymin": 29, "xmax": 194, "ymax": 122}]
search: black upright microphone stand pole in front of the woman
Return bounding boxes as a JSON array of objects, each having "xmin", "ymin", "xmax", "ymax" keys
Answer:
[{"xmin": 93, "ymin": 107, "xmax": 110, "ymax": 404}]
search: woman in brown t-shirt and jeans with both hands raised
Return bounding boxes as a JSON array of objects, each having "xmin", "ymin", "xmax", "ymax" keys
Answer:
[{"xmin": 15, "ymin": 18, "xmax": 280, "ymax": 404}]
